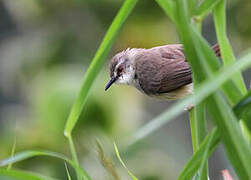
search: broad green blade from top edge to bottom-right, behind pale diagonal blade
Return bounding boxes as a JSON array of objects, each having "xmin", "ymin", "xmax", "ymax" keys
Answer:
[{"xmin": 158, "ymin": 0, "xmax": 251, "ymax": 179}]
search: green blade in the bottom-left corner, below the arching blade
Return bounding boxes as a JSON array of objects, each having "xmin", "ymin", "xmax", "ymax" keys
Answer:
[{"xmin": 0, "ymin": 168, "xmax": 56, "ymax": 180}]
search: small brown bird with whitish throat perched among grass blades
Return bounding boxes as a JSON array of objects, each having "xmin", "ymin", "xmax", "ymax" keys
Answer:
[{"xmin": 105, "ymin": 44, "xmax": 220, "ymax": 100}]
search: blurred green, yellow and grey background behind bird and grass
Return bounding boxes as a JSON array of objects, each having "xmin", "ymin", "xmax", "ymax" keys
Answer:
[{"xmin": 0, "ymin": 0, "xmax": 251, "ymax": 180}]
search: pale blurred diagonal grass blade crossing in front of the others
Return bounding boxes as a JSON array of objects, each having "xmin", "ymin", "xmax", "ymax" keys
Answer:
[{"xmin": 129, "ymin": 53, "xmax": 251, "ymax": 143}]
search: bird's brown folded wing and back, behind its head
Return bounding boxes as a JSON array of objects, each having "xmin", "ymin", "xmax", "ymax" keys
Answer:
[{"xmin": 136, "ymin": 45, "xmax": 192, "ymax": 94}]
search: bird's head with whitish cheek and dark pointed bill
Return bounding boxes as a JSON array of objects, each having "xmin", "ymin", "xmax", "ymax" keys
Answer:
[{"xmin": 105, "ymin": 49, "xmax": 137, "ymax": 90}]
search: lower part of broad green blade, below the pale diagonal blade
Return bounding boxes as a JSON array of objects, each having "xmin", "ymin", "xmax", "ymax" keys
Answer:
[{"xmin": 208, "ymin": 93, "xmax": 251, "ymax": 179}]
